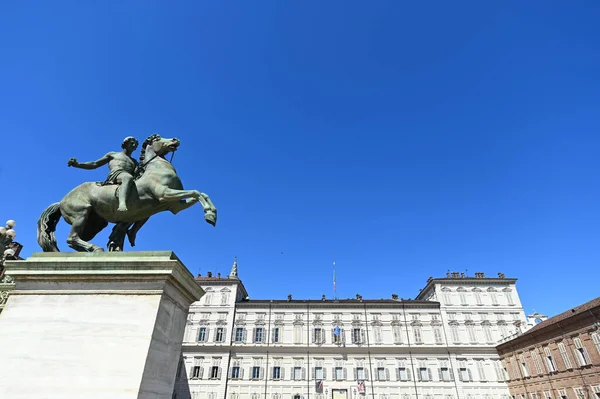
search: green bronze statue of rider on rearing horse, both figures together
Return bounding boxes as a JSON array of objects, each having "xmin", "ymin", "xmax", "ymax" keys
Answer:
[{"xmin": 37, "ymin": 134, "xmax": 217, "ymax": 252}]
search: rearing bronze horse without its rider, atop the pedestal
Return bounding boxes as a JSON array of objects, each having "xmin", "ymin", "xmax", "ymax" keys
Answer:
[{"xmin": 37, "ymin": 134, "xmax": 217, "ymax": 252}]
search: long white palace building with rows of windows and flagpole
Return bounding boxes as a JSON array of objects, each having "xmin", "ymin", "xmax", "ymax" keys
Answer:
[{"xmin": 174, "ymin": 262, "xmax": 526, "ymax": 399}]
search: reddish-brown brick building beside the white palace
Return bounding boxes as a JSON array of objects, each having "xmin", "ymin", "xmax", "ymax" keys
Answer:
[{"xmin": 497, "ymin": 298, "xmax": 600, "ymax": 399}]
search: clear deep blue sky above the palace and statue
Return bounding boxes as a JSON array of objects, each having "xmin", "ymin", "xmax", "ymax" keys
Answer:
[{"xmin": 0, "ymin": 0, "xmax": 600, "ymax": 314}]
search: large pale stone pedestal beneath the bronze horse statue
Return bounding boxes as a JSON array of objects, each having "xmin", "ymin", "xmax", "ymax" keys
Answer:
[{"xmin": 0, "ymin": 252, "xmax": 204, "ymax": 399}]
